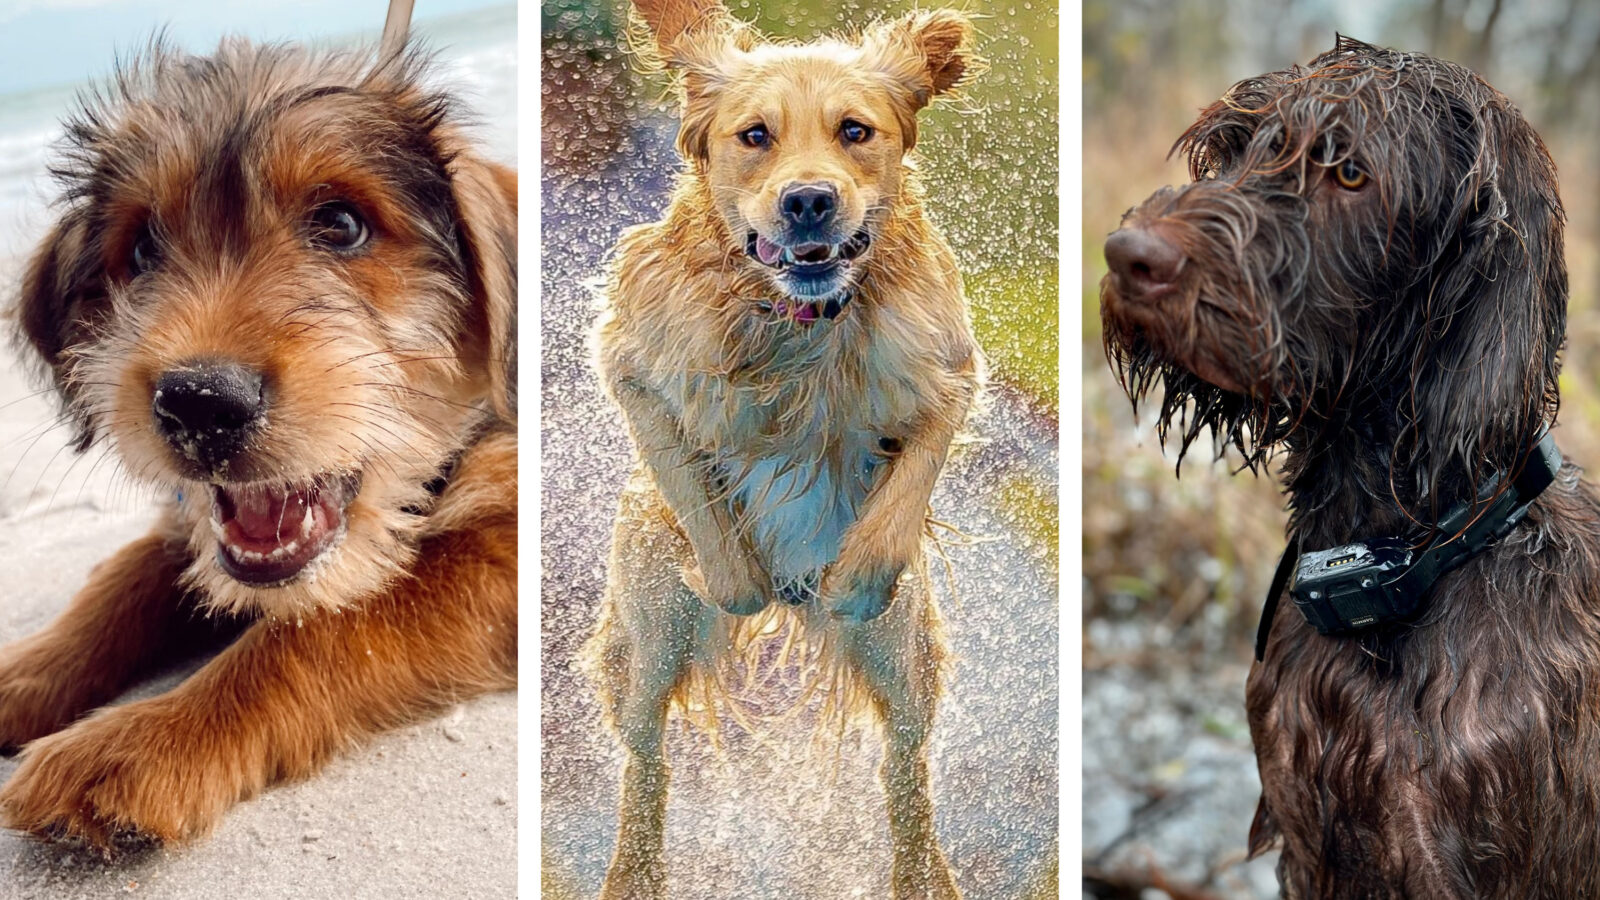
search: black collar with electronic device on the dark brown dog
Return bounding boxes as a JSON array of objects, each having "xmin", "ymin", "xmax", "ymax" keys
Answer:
[{"xmin": 1256, "ymin": 431, "xmax": 1562, "ymax": 661}]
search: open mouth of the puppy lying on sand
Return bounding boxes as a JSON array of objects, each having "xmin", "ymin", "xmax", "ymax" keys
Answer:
[{"xmin": 211, "ymin": 474, "xmax": 362, "ymax": 585}]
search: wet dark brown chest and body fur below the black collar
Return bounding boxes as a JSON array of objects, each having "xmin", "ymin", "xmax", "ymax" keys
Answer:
[{"xmin": 1246, "ymin": 485, "xmax": 1600, "ymax": 897}]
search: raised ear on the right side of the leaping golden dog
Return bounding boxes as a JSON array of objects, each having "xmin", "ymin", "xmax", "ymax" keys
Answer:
[{"xmin": 861, "ymin": 10, "xmax": 981, "ymax": 147}]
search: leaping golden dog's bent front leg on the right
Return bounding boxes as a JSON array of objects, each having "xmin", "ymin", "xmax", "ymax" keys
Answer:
[{"xmin": 821, "ymin": 404, "xmax": 965, "ymax": 621}]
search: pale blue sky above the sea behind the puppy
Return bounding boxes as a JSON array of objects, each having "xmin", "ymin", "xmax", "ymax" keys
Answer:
[{"xmin": 0, "ymin": 0, "xmax": 504, "ymax": 95}]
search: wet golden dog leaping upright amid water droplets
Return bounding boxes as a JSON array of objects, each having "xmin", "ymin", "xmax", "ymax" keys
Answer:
[{"xmin": 590, "ymin": 0, "xmax": 982, "ymax": 900}]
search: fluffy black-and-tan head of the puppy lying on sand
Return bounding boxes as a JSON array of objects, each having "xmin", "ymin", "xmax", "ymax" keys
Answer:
[{"xmin": 21, "ymin": 45, "xmax": 515, "ymax": 617}]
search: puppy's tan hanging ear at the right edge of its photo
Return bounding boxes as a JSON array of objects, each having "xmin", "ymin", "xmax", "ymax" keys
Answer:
[{"xmin": 451, "ymin": 155, "xmax": 517, "ymax": 423}]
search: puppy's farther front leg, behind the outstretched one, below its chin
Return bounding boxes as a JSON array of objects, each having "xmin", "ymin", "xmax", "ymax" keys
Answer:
[{"xmin": 0, "ymin": 528, "xmax": 202, "ymax": 748}]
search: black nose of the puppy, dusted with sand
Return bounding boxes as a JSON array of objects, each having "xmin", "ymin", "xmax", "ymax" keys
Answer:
[{"xmin": 150, "ymin": 360, "xmax": 267, "ymax": 472}]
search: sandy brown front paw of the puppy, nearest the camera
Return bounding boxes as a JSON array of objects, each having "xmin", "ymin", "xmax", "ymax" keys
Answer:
[{"xmin": 0, "ymin": 698, "xmax": 242, "ymax": 854}]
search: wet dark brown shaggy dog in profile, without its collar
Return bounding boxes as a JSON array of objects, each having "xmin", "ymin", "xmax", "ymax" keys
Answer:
[{"xmin": 1102, "ymin": 38, "xmax": 1600, "ymax": 898}]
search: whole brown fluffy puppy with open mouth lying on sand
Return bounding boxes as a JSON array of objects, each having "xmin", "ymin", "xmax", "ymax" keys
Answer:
[{"xmin": 0, "ymin": 43, "xmax": 517, "ymax": 847}]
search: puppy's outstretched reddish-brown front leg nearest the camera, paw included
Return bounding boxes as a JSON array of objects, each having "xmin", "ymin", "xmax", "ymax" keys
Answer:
[{"xmin": 0, "ymin": 522, "xmax": 517, "ymax": 847}]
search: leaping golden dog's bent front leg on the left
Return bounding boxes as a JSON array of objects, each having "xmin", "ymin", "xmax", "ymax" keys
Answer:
[{"xmin": 613, "ymin": 380, "xmax": 773, "ymax": 615}]
